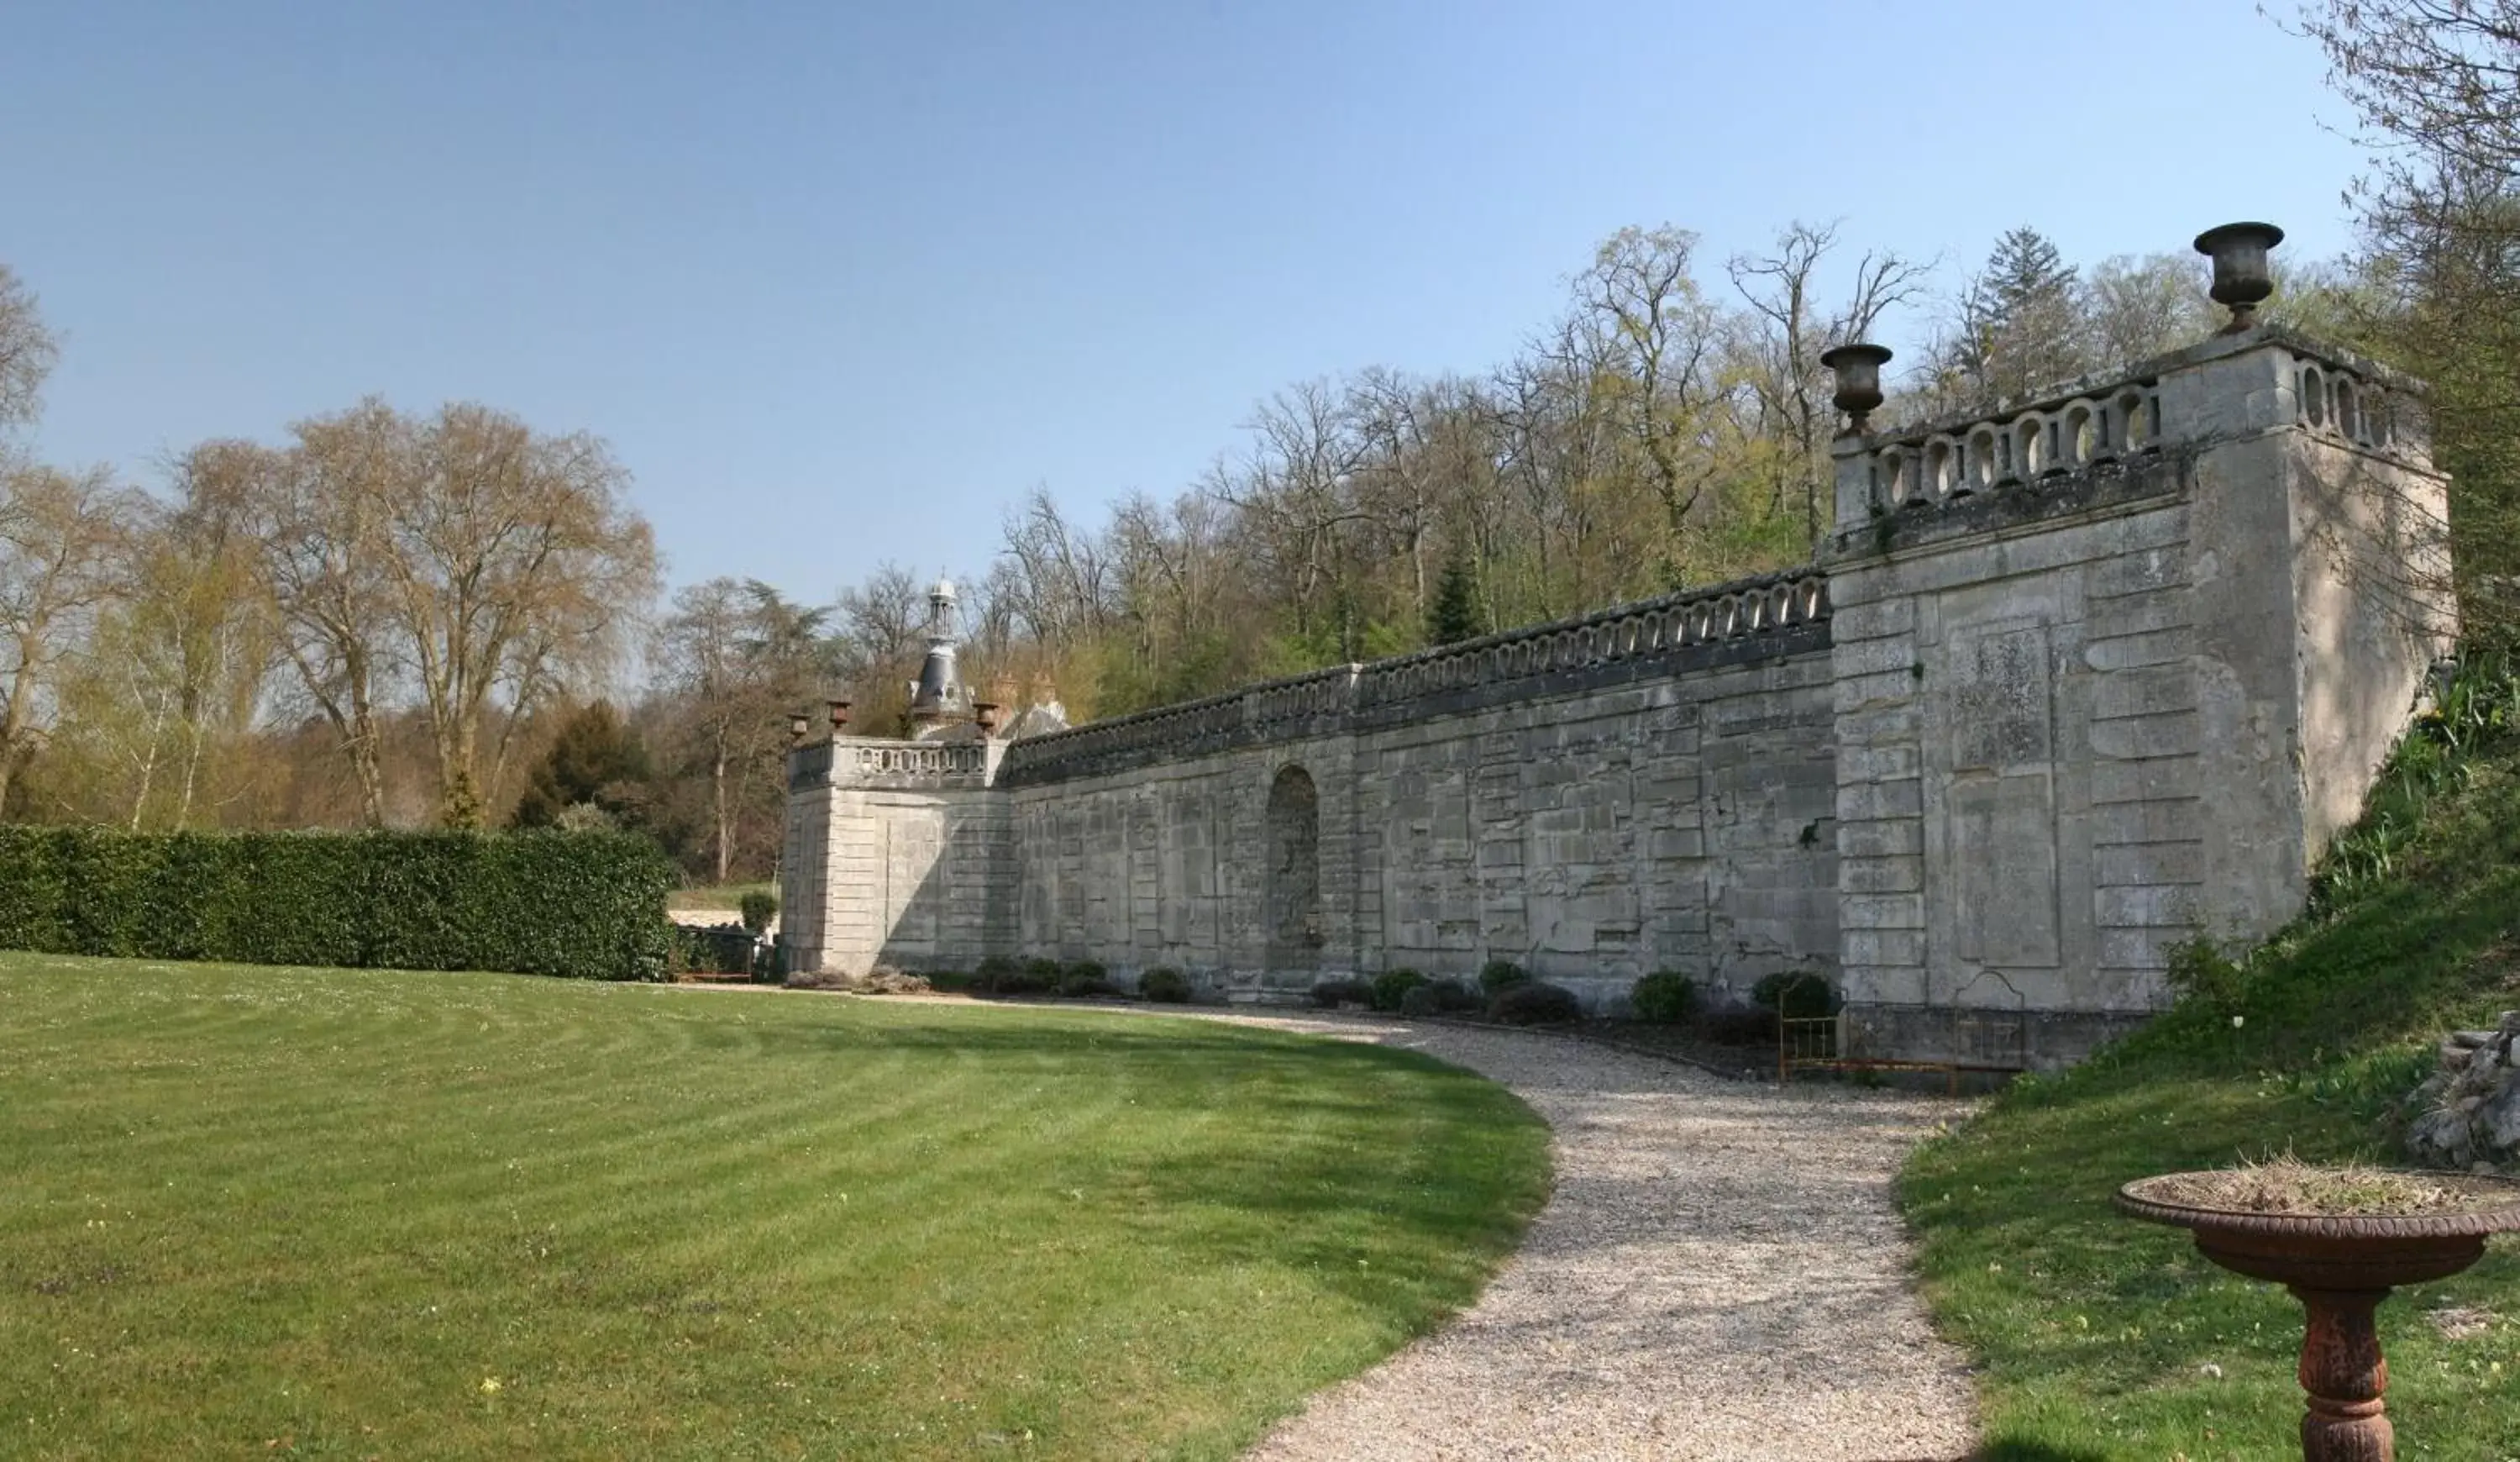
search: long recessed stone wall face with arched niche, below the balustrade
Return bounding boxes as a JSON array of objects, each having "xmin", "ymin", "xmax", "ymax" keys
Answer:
[{"xmin": 993, "ymin": 618, "xmax": 1837, "ymax": 1003}]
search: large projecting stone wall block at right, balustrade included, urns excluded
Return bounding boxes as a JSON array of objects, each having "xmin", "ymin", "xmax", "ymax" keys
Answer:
[{"xmin": 1830, "ymin": 330, "xmax": 2449, "ymax": 1064}]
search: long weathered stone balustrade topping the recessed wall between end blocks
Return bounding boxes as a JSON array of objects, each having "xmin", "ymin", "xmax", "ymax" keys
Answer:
[{"xmin": 1003, "ymin": 570, "xmax": 1830, "ymax": 776}]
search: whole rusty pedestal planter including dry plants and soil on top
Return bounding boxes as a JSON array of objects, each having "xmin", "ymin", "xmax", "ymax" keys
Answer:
[{"xmin": 2117, "ymin": 1165, "xmax": 2520, "ymax": 1462}]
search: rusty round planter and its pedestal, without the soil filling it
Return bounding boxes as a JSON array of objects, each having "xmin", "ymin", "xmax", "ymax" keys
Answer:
[{"xmin": 2117, "ymin": 1172, "xmax": 2520, "ymax": 1462}]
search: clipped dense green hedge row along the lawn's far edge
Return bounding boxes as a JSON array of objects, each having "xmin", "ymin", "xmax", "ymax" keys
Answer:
[{"xmin": 0, "ymin": 824, "xmax": 673, "ymax": 981}]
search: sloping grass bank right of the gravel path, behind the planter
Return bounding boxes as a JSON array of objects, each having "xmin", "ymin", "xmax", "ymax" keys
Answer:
[{"xmin": 1900, "ymin": 671, "xmax": 2520, "ymax": 1462}]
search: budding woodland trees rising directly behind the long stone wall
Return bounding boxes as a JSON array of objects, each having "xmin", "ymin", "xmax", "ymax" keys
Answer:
[{"xmin": 842, "ymin": 224, "xmax": 2376, "ymax": 728}]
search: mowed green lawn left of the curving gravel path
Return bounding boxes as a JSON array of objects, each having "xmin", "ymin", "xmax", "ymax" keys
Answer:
[{"xmin": 0, "ymin": 953, "xmax": 1547, "ymax": 1459}]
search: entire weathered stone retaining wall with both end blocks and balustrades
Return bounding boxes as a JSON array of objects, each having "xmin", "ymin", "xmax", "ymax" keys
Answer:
[{"xmin": 786, "ymin": 330, "xmax": 2447, "ymax": 1066}]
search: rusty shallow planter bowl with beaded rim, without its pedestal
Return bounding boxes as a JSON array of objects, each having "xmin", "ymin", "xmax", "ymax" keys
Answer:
[{"xmin": 2117, "ymin": 1172, "xmax": 2520, "ymax": 1291}]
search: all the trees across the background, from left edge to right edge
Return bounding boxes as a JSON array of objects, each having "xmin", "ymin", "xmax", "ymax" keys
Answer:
[{"xmin": 0, "ymin": 0, "xmax": 2520, "ymax": 880}]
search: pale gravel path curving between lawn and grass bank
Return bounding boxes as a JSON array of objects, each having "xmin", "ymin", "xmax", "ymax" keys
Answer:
[{"xmin": 1189, "ymin": 1016, "xmax": 1976, "ymax": 1462}]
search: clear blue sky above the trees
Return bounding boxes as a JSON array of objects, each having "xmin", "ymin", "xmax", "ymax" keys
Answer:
[{"xmin": 0, "ymin": 0, "xmax": 2359, "ymax": 600}]
